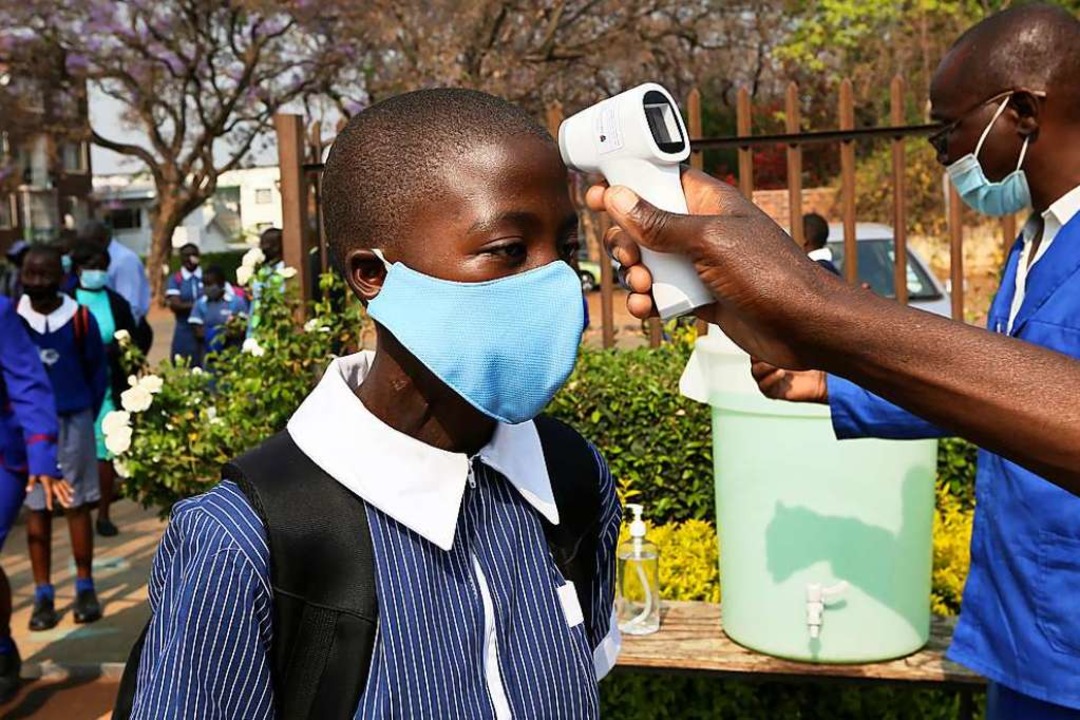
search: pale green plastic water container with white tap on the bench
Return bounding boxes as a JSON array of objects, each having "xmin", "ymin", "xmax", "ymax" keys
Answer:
[{"xmin": 680, "ymin": 327, "xmax": 937, "ymax": 663}]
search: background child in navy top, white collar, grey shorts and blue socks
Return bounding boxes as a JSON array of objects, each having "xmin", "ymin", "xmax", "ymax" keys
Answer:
[{"xmin": 18, "ymin": 247, "xmax": 108, "ymax": 630}]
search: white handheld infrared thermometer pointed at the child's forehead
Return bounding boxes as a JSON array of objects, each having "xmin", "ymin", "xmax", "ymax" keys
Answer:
[{"xmin": 558, "ymin": 82, "xmax": 715, "ymax": 320}]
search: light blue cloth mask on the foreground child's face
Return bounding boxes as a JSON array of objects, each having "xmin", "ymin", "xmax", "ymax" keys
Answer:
[{"xmin": 367, "ymin": 250, "xmax": 584, "ymax": 424}]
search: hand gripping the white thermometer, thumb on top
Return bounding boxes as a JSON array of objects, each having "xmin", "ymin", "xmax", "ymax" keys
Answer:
[{"xmin": 586, "ymin": 169, "xmax": 846, "ymax": 368}]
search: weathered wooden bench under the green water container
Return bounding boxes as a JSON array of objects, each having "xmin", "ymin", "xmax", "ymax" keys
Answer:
[{"xmin": 618, "ymin": 602, "xmax": 986, "ymax": 718}]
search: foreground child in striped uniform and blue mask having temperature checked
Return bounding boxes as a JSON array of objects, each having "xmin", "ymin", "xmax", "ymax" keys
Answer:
[{"xmin": 120, "ymin": 90, "xmax": 620, "ymax": 720}]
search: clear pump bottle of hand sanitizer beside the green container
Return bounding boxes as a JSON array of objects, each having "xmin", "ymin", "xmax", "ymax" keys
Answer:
[{"xmin": 618, "ymin": 504, "xmax": 660, "ymax": 635}]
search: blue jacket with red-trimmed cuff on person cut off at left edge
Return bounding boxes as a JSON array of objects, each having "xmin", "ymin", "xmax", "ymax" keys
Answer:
[{"xmin": 0, "ymin": 297, "xmax": 59, "ymax": 476}]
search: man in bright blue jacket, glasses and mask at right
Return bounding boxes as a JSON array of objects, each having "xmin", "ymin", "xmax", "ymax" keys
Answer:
[{"xmin": 754, "ymin": 5, "xmax": 1080, "ymax": 720}]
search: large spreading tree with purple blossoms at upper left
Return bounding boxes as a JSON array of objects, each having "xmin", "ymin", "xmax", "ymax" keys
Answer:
[{"xmin": 0, "ymin": 0, "xmax": 355, "ymax": 298}]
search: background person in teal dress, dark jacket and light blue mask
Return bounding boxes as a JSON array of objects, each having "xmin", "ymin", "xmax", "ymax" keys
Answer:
[{"xmin": 71, "ymin": 242, "xmax": 137, "ymax": 538}]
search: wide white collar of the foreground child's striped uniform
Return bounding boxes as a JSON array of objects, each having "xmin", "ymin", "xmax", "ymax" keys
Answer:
[{"xmin": 288, "ymin": 352, "xmax": 558, "ymax": 551}]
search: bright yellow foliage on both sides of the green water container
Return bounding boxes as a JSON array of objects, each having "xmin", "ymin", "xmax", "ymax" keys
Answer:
[{"xmin": 619, "ymin": 489, "xmax": 972, "ymax": 615}]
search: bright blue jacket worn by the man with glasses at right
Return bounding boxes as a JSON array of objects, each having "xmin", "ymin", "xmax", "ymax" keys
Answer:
[{"xmin": 828, "ymin": 215, "xmax": 1080, "ymax": 708}]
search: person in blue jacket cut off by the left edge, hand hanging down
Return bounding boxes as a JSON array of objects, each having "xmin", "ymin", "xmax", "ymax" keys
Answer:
[{"xmin": 0, "ymin": 297, "xmax": 71, "ymax": 703}]
